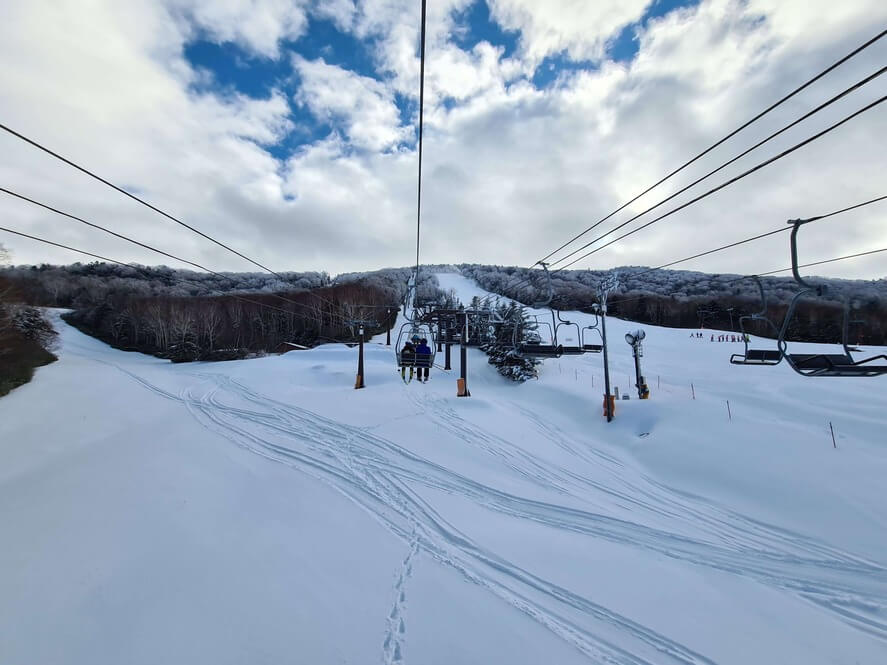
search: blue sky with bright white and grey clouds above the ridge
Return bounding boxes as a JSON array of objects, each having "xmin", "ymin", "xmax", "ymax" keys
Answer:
[{"xmin": 0, "ymin": 0, "xmax": 887, "ymax": 279}]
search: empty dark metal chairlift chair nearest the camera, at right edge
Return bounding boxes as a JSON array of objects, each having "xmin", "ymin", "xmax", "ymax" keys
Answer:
[{"xmin": 778, "ymin": 219, "xmax": 887, "ymax": 376}]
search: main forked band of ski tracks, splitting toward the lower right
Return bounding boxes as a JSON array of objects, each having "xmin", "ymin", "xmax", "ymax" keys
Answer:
[{"xmin": 102, "ymin": 370, "xmax": 887, "ymax": 665}]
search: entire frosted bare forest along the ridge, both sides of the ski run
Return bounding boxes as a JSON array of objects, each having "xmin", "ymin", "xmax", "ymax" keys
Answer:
[{"xmin": 0, "ymin": 256, "xmax": 887, "ymax": 370}]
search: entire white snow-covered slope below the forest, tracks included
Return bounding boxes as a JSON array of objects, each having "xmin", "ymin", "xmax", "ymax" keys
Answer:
[{"xmin": 0, "ymin": 275, "xmax": 887, "ymax": 665}]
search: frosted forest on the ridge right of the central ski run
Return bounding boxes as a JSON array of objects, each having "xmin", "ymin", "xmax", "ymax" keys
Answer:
[{"xmin": 460, "ymin": 264, "xmax": 887, "ymax": 345}]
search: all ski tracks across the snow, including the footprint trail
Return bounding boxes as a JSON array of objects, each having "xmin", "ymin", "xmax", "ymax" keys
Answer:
[{"xmin": 81, "ymin": 363, "xmax": 887, "ymax": 665}]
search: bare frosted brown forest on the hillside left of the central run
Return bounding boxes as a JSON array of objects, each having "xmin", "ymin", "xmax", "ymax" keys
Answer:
[{"xmin": 0, "ymin": 263, "xmax": 438, "ymax": 362}]
